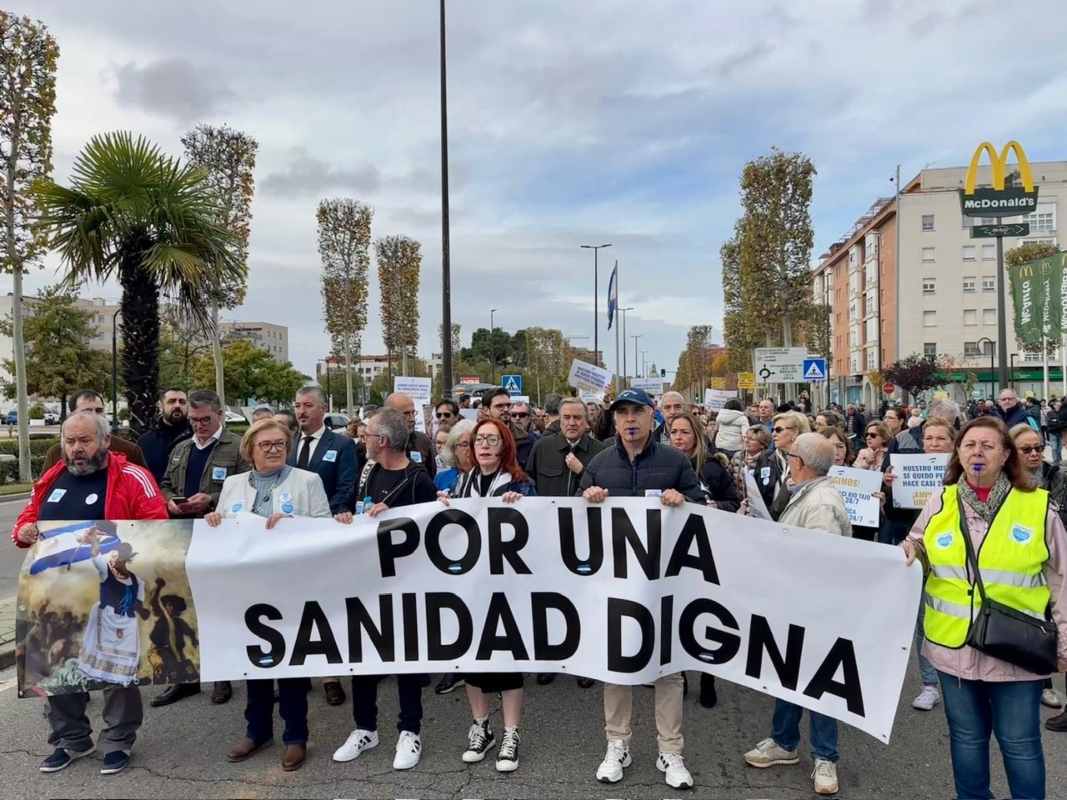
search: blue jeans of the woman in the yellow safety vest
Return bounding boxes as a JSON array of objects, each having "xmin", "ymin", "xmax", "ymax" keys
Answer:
[{"xmin": 939, "ymin": 672, "xmax": 1045, "ymax": 800}]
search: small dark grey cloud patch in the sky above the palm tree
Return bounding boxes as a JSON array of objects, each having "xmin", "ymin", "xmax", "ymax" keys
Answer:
[{"xmin": 114, "ymin": 58, "xmax": 235, "ymax": 123}]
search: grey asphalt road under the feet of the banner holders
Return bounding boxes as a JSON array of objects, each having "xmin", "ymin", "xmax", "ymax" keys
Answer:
[{"xmin": 0, "ymin": 665, "xmax": 1067, "ymax": 800}]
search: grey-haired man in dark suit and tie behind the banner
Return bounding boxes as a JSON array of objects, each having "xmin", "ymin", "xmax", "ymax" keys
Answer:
[{"xmin": 289, "ymin": 386, "xmax": 356, "ymax": 705}]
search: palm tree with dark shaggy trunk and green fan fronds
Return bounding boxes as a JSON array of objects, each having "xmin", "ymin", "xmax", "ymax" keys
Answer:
[{"xmin": 34, "ymin": 131, "xmax": 240, "ymax": 432}]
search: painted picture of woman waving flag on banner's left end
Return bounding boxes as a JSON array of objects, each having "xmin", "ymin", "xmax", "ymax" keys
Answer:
[{"xmin": 16, "ymin": 519, "xmax": 200, "ymax": 695}]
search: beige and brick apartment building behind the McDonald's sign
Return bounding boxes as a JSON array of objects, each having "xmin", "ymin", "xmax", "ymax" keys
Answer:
[{"xmin": 813, "ymin": 161, "xmax": 1067, "ymax": 404}]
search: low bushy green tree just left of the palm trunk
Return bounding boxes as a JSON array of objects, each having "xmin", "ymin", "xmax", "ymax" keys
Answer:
[{"xmin": 3, "ymin": 286, "xmax": 111, "ymax": 416}]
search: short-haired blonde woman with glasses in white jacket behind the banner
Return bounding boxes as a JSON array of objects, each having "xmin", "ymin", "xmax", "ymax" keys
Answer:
[{"xmin": 204, "ymin": 418, "xmax": 347, "ymax": 772}]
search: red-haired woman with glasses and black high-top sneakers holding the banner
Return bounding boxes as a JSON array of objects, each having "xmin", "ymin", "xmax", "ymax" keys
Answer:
[{"xmin": 439, "ymin": 418, "xmax": 536, "ymax": 772}]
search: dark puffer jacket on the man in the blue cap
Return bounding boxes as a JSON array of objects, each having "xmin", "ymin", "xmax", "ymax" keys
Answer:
[{"xmin": 582, "ymin": 436, "xmax": 704, "ymax": 505}]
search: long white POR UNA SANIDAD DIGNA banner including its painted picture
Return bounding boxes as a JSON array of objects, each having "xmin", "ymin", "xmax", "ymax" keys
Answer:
[{"xmin": 18, "ymin": 497, "xmax": 921, "ymax": 741}]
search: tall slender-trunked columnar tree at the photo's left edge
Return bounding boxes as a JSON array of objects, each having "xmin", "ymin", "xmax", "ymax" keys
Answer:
[{"xmin": 0, "ymin": 11, "xmax": 60, "ymax": 481}]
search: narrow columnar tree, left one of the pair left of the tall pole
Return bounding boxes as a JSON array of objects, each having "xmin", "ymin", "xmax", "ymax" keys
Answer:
[{"xmin": 316, "ymin": 197, "xmax": 375, "ymax": 409}]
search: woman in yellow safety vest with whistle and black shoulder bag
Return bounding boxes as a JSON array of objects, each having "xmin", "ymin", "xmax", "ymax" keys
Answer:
[{"xmin": 902, "ymin": 417, "xmax": 1067, "ymax": 798}]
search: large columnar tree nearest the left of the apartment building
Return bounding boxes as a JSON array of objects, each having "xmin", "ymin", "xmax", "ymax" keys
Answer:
[{"xmin": 720, "ymin": 148, "xmax": 815, "ymax": 369}]
